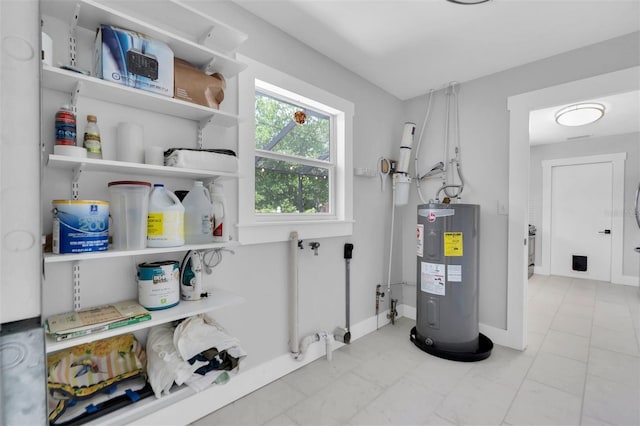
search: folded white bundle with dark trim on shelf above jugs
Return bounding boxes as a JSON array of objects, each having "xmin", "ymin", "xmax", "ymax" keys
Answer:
[{"xmin": 164, "ymin": 148, "xmax": 238, "ymax": 173}]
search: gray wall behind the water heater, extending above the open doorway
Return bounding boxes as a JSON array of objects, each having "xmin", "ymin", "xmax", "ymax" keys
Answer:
[{"xmin": 401, "ymin": 32, "xmax": 640, "ymax": 329}]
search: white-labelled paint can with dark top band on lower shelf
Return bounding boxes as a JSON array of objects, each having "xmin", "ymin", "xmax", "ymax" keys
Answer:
[{"xmin": 138, "ymin": 260, "xmax": 180, "ymax": 310}]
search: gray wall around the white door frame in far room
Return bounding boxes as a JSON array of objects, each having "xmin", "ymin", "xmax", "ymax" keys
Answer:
[{"xmin": 529, "ymin": 133, "xmax": 640, "ymax": 276}]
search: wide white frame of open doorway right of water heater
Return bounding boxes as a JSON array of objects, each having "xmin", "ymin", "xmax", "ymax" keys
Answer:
[{"xmin": 504, "ymin": 66, "xmax": 640, "ymax": 350}]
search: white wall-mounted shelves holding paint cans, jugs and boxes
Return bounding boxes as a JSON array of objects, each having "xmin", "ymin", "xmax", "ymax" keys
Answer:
[{"xmin": 40, "ymin": 0, "xmax": 247, "ymax": 424}]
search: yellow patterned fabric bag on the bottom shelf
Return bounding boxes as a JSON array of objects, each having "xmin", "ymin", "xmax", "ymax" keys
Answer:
[{"xmin": 47, "ymin": 334, "xmax": 146, "ymax": 422}]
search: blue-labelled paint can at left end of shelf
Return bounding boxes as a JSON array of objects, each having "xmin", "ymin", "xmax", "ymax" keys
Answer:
[{"xmin": 52, "ymin": 200, "xmax": 109, "ymax": 254}]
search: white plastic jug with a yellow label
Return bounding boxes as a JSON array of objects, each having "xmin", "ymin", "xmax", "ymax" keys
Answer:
[{"xmin": 147, "ymin": 183, "xmax": 184, "ymax": 247}]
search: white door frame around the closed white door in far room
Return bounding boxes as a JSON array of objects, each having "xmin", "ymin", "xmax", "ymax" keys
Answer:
[{"xmin": 536, "ymin": 152, "xmax": 627, "ymax": 284}]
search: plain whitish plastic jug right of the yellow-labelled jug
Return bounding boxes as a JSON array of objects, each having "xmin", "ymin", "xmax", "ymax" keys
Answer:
[{"xmin": 182, "ymin": 181, "xmax": 213, "ymax": 244}]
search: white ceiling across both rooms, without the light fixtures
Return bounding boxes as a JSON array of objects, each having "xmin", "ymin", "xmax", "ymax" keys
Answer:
[{"xmin": 234, "ymin": 0, "xmax": 640, "ymax": 143}]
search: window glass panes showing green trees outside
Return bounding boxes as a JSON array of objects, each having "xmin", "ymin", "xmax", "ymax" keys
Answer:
[{"xmin": 255, "ymin": 91, "xmax": 333, "ymax": 214}]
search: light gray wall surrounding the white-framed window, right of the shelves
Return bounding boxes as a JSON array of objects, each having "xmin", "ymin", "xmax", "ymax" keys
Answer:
[{"xmin": 182, "ymin": 1, "xmax": 408, "ymax": 367}]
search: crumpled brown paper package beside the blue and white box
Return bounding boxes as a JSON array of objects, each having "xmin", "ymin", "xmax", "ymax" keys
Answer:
[{"xmin": 173, "ymin": 58, "xmax": 226, "ymax": 109}]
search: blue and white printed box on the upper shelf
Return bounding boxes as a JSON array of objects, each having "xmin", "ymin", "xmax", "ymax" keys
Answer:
[{"xmin": 93, "ymin": 25, "xmax": 173, "ymax": 97}]
